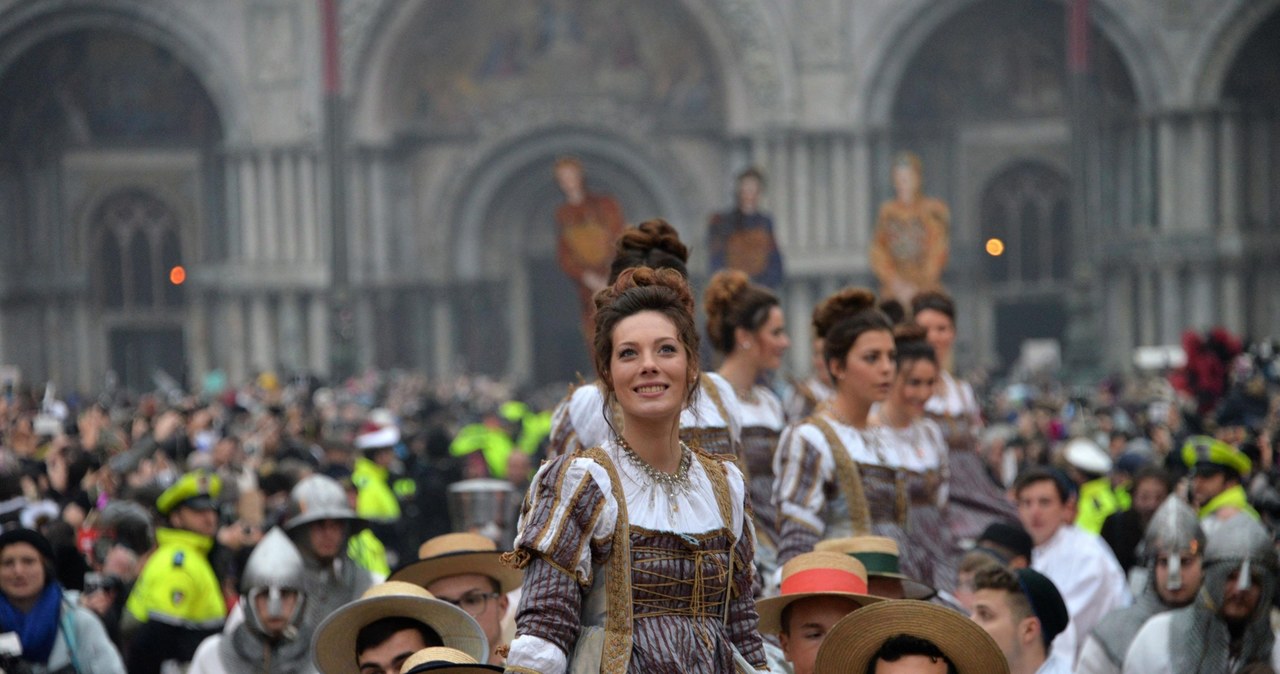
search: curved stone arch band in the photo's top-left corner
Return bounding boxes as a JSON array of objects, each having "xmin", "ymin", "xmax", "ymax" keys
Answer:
[{"xmin": 0, "ymin": 0, "xmax": 251, "ymax": 146}]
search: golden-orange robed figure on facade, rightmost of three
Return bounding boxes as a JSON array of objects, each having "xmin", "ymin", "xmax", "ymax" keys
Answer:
[{"xmin": 870, "ymin": 152, "xmax": 951, "ymax": 307}]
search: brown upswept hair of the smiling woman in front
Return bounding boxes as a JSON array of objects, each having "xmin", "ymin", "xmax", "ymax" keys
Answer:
[{"xmin": 593, "ymin": 267, "xmax": 700, "ymax": 405}]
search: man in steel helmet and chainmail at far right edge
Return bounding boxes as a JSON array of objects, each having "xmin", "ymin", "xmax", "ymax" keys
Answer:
[{"xmin": 1123, "ymin": 517, "xmax": 1277, "ymax": 674}]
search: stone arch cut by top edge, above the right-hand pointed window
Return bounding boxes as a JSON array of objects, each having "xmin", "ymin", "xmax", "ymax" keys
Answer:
[{"xmin": 849, "ymin": 0, "xmax": 1174, "ymax": 128}]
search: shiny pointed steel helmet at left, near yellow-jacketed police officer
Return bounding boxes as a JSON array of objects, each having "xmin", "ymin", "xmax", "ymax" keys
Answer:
[{"xmin": 241, "ymin": 527, "xmax": 306, "ymax": 639}]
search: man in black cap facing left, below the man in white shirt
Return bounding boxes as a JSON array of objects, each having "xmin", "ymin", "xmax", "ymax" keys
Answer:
[{"xmin": 969, "ymin": 567, "xmax": 1071, "ymax": 674}]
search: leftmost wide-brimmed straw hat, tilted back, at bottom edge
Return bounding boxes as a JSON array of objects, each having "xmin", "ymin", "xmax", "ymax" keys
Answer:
[{"xmin": 311, "ymin": 581, "xmax": 489, "ymax": 674}]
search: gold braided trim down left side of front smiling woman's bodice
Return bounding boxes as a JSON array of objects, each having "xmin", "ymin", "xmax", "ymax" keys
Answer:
[{"xmin": 582, "ymin": 448, "xmax": 632, "ymax": 674}]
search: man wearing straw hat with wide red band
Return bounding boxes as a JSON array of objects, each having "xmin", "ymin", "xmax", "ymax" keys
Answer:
[{"xmin": 755, "ymin": 553, "xmax": 881, "ymax": 674}]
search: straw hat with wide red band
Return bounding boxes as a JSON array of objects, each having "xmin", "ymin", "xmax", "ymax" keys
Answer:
[{"xmin": 755, "ymin": 553, "xmax": 883, "ymax": 634}]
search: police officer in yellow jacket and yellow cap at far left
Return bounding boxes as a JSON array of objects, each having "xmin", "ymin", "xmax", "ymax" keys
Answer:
[{"xmin": 123, "ymin": 472, "xmax": 227, "ymax": 674}]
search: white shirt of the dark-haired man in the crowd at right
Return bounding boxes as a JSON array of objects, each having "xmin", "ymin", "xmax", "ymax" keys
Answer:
[{"xmin": 1032, "ymin": 524, "xmax": 1133, "ymax": 666}]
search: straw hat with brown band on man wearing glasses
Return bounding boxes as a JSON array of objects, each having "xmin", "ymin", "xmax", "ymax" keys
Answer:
[{"xmin": 389, "ymin": 533, "xmax": 525, "ymax": 592}]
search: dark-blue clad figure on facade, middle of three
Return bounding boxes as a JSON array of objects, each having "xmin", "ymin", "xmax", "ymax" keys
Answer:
[{"xmin": 707, "ymin": 168, "xmax": 782, "ymax": 289}]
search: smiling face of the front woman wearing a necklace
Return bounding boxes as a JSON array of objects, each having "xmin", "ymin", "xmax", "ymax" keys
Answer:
[{"xmin": 609, "ymin": 311, "xmax": 692, "ymax": 418}]
